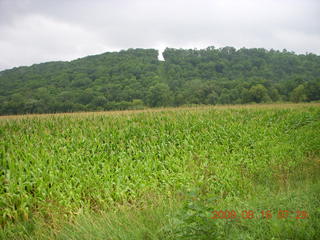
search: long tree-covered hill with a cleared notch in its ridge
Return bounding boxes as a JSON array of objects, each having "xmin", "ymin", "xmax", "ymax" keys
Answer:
[{"xmin": 0, "ymin": 47, "xmax": 320, "ymax": 115}]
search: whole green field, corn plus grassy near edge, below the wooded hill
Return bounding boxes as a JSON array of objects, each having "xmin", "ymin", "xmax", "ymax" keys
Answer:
[{"xmin": 0, "ymin": 104, "xmax": 320, "ymax": 239}]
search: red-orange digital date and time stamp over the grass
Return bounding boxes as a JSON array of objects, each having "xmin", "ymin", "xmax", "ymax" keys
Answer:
[{"xmin": 210, "ymin": 209, "xmax": 309, "ymax": 220}]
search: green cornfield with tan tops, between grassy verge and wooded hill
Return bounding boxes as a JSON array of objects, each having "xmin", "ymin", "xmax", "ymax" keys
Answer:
[{"xmin": 0, "ymin": 104, "xmax": 320, "ymax": 239}]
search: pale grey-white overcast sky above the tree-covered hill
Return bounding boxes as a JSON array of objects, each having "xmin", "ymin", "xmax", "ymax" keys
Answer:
[{"xmin": 0, "ymin": 0, "xmax": 320, "ymax": 70}]
